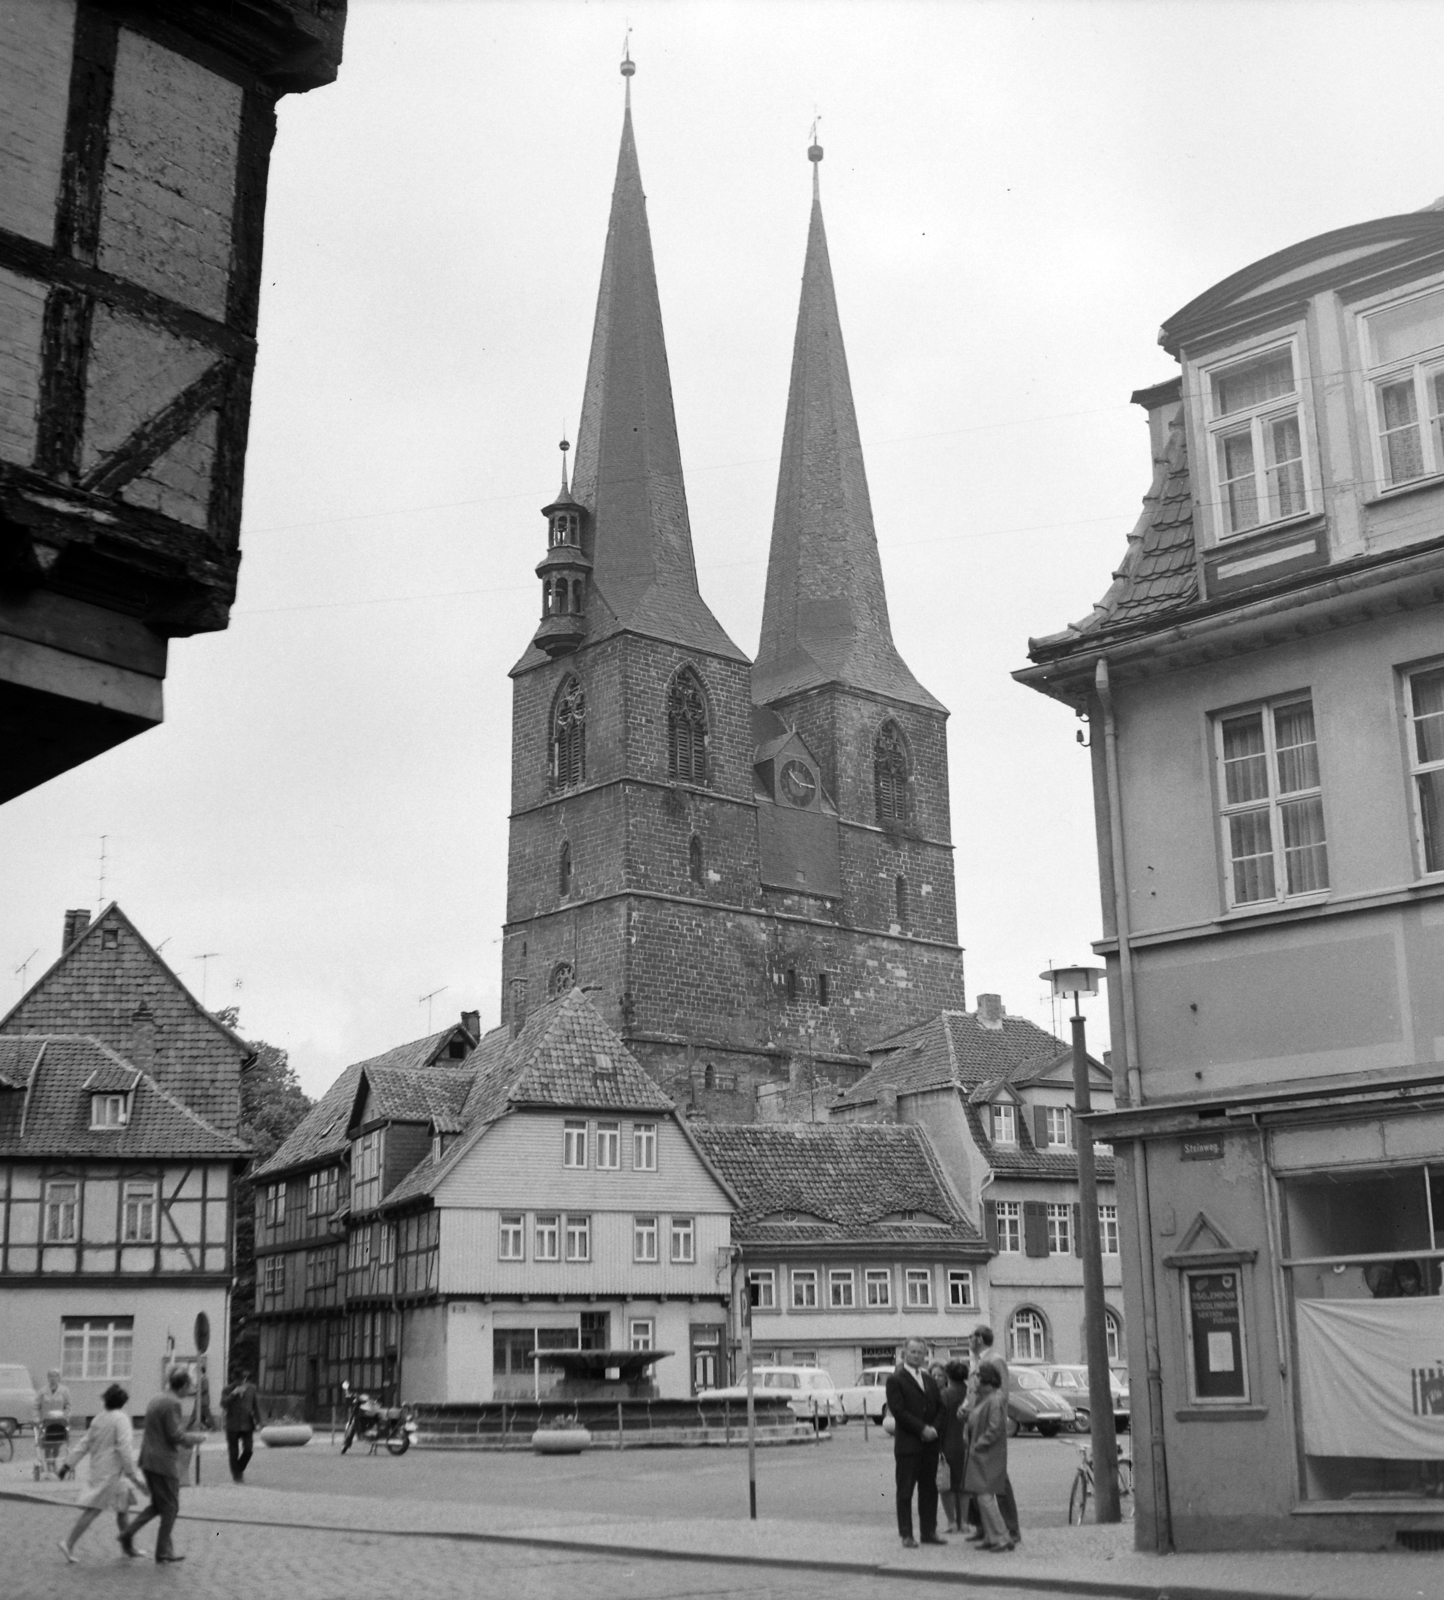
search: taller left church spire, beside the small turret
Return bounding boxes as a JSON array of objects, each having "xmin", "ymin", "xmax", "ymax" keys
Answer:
[{"xmin": 572, "ymin": 56, "xmax": 746, "ymax": 661}]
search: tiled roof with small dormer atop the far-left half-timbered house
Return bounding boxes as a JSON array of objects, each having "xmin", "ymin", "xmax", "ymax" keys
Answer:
[{"xmin": 0, "ymin": 1034, "xmax": 247, "ymax": 1160}]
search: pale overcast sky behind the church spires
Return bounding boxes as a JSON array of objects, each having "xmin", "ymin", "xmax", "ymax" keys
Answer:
[{"xmin": 0, "ymin": 0, "xmax": 1444, "ymax": 1093}]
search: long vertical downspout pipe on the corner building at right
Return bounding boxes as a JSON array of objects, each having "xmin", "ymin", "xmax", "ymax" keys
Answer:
[{"xmin": 1093, "ymin": 656, "xmax": 1173, "ymax": 1550}]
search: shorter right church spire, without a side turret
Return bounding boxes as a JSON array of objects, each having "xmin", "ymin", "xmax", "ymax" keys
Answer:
[{"xmin": 752, "ymin": 140, "xmax": 943, "ymax": 710}]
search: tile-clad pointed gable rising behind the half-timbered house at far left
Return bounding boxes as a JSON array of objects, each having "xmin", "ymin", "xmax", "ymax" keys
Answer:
[{"xmin": 0, "ymin": 901, "xmax": 253, "ymax": 1133}]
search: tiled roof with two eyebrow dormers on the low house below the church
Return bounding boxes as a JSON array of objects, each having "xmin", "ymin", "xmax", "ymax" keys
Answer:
[{"xmin": 692, "ymin": 1122, "xmax": 986, "ymax": 1251}]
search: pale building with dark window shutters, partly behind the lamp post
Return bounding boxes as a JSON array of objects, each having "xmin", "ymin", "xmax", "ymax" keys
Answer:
[{"xmin": 829, "ymin": 995, "xmax": 1127, "ymax": 1368}]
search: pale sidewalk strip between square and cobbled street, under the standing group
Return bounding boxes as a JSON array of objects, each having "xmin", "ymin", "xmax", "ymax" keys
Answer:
[{"xmin": 0, "ymin": 1448, "xmax": 1444, "ymax": 1600}]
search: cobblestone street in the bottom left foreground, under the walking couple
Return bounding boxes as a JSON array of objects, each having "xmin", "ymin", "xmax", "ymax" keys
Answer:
[{"xmin": 0, "ymin": 1501, "xmax": 1020, "ymax": 1600}]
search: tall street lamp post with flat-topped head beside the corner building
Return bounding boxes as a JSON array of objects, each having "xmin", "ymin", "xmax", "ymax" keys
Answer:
[{"xmin": 1039, "ymin": 966, "xmax": 1119, "ymax": 1522}]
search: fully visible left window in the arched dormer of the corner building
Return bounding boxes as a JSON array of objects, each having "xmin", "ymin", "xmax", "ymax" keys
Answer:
[{"xmin": 1207, "ymin": 344, "xmax": 1308, "ymax": 534}]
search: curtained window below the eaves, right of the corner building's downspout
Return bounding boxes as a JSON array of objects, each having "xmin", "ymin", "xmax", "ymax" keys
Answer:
[{"xmin": 1217, "ymin": 699, "xmax": 1329, "ymax": 906}]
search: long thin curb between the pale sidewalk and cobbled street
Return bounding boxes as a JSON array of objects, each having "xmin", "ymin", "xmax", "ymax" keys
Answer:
[{"xmin": 0, "ymin": 1490, "xmax": 1331, "ymax": 1600}]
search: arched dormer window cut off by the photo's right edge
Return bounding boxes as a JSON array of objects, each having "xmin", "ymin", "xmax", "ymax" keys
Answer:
[{"xmin": 1364, "ymin": 290, "xmax": 1444, "ymax": 488}]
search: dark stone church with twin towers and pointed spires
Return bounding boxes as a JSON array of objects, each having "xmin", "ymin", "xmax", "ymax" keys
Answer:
[{"xmin": 503, "ymin": 84, "xmax": 965, "ymax": 1122}]
